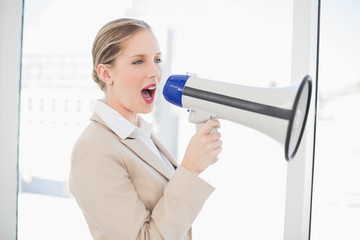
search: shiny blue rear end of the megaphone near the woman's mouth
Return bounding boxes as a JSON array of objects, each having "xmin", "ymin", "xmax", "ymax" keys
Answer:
[{"xmin": 163, "ymin": 75, "xmax": 190, "ymax": 107}]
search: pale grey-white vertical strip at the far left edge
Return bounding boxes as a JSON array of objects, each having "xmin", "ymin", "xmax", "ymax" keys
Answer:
[{"xmin": 0, "ymin": 0, "xmax": 23, "ymax": 239}]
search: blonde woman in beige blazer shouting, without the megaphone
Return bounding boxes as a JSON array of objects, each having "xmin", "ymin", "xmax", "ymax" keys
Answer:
[{"xmin": 70, "ymin": 19, "xmax": 222, "ymax": 240}]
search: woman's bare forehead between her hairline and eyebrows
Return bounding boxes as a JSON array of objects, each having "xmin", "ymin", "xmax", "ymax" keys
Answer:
[{"xmin": 122, "ymin": 30, "xmax": 160, "ymax": 55}]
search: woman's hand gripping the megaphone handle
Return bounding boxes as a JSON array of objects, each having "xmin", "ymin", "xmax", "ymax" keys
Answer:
[{"xmin": 181, "ymin": 119, "xmax": 222, "ymax": 174}]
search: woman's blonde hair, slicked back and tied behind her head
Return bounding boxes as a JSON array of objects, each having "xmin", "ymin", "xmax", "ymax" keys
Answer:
[{"xmin": 92, "ymin": 18, "xmax": 151, "ymax": 91}]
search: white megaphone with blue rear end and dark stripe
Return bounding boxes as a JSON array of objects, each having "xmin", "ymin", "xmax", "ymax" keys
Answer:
[{"xmin": 163, "ymin": 75, "xmax": 312, "ymax": 161}]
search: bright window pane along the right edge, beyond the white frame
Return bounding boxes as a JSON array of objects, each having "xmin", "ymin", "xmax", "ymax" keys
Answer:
[{"xmin": 311, "ymin": 0, "xmax": 360, "ymax": 240}]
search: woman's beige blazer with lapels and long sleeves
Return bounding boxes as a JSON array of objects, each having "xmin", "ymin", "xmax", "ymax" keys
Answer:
[{"xmin": 70, "ymin": 113, "xmax": 214, "ymax": 240}]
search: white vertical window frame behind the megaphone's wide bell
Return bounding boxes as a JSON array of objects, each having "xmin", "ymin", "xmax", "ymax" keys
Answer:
[{"xmin": 284, "ymin": 0, "xmax": 320, "ymax": 240}]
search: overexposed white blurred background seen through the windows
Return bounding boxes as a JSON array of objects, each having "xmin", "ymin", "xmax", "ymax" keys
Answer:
[{"xmin": 18, "ymin": 0, "xmax": 360, "ymax": 240}]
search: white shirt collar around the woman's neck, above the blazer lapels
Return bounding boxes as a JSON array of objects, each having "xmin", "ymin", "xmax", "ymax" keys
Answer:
[{"xmin": 94, "ymin": 100, "xmax": 153, "ymax": 139}]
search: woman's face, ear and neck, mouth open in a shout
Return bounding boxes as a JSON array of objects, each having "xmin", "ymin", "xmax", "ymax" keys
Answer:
[{"xmin": 105, "ymin": 30, "xmax": 161, "ymax": 124}]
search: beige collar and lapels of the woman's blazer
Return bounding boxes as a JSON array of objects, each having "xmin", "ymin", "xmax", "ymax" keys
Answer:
[{"xmin": 90, "ymin": 113, "xmax": 177, "ymax": 180}]
